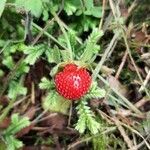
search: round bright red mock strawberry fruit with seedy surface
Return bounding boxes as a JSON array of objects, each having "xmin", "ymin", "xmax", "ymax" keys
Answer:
[{"xmin": 55, "ymin": 64, "xmax": 92, "ymax": 100}]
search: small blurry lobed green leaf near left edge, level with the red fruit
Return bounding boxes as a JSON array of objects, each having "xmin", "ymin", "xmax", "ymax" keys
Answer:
[{"xmin": 8, "ymin": 81, "xmax": 27, "ymax": 99}]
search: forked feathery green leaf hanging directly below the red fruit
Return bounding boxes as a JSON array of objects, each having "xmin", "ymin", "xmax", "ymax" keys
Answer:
[{"xmin": 75, "ymin": 99, "xmax": 100, "ymax": 134}]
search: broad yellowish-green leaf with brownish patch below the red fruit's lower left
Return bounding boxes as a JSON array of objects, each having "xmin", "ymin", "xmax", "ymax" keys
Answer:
[{"xmin": 43, "ymin": 91, "xmax": 71, "ymax": 114}]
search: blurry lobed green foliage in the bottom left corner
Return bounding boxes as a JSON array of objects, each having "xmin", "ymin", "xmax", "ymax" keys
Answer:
[{"xmin": 3, "ymin": 114, "xmax": 30, "ymax": 150}]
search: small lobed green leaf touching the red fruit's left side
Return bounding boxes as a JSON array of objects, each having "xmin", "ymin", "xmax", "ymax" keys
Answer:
[{"xmin": 39, "ymin": 77, "xmax": 54, "ymax": 90}]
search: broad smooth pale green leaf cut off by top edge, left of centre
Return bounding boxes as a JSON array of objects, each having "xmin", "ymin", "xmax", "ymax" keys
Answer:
[{"xmin": 15, "ymin": 0, "xmax": 43, "ymax": 18}]
